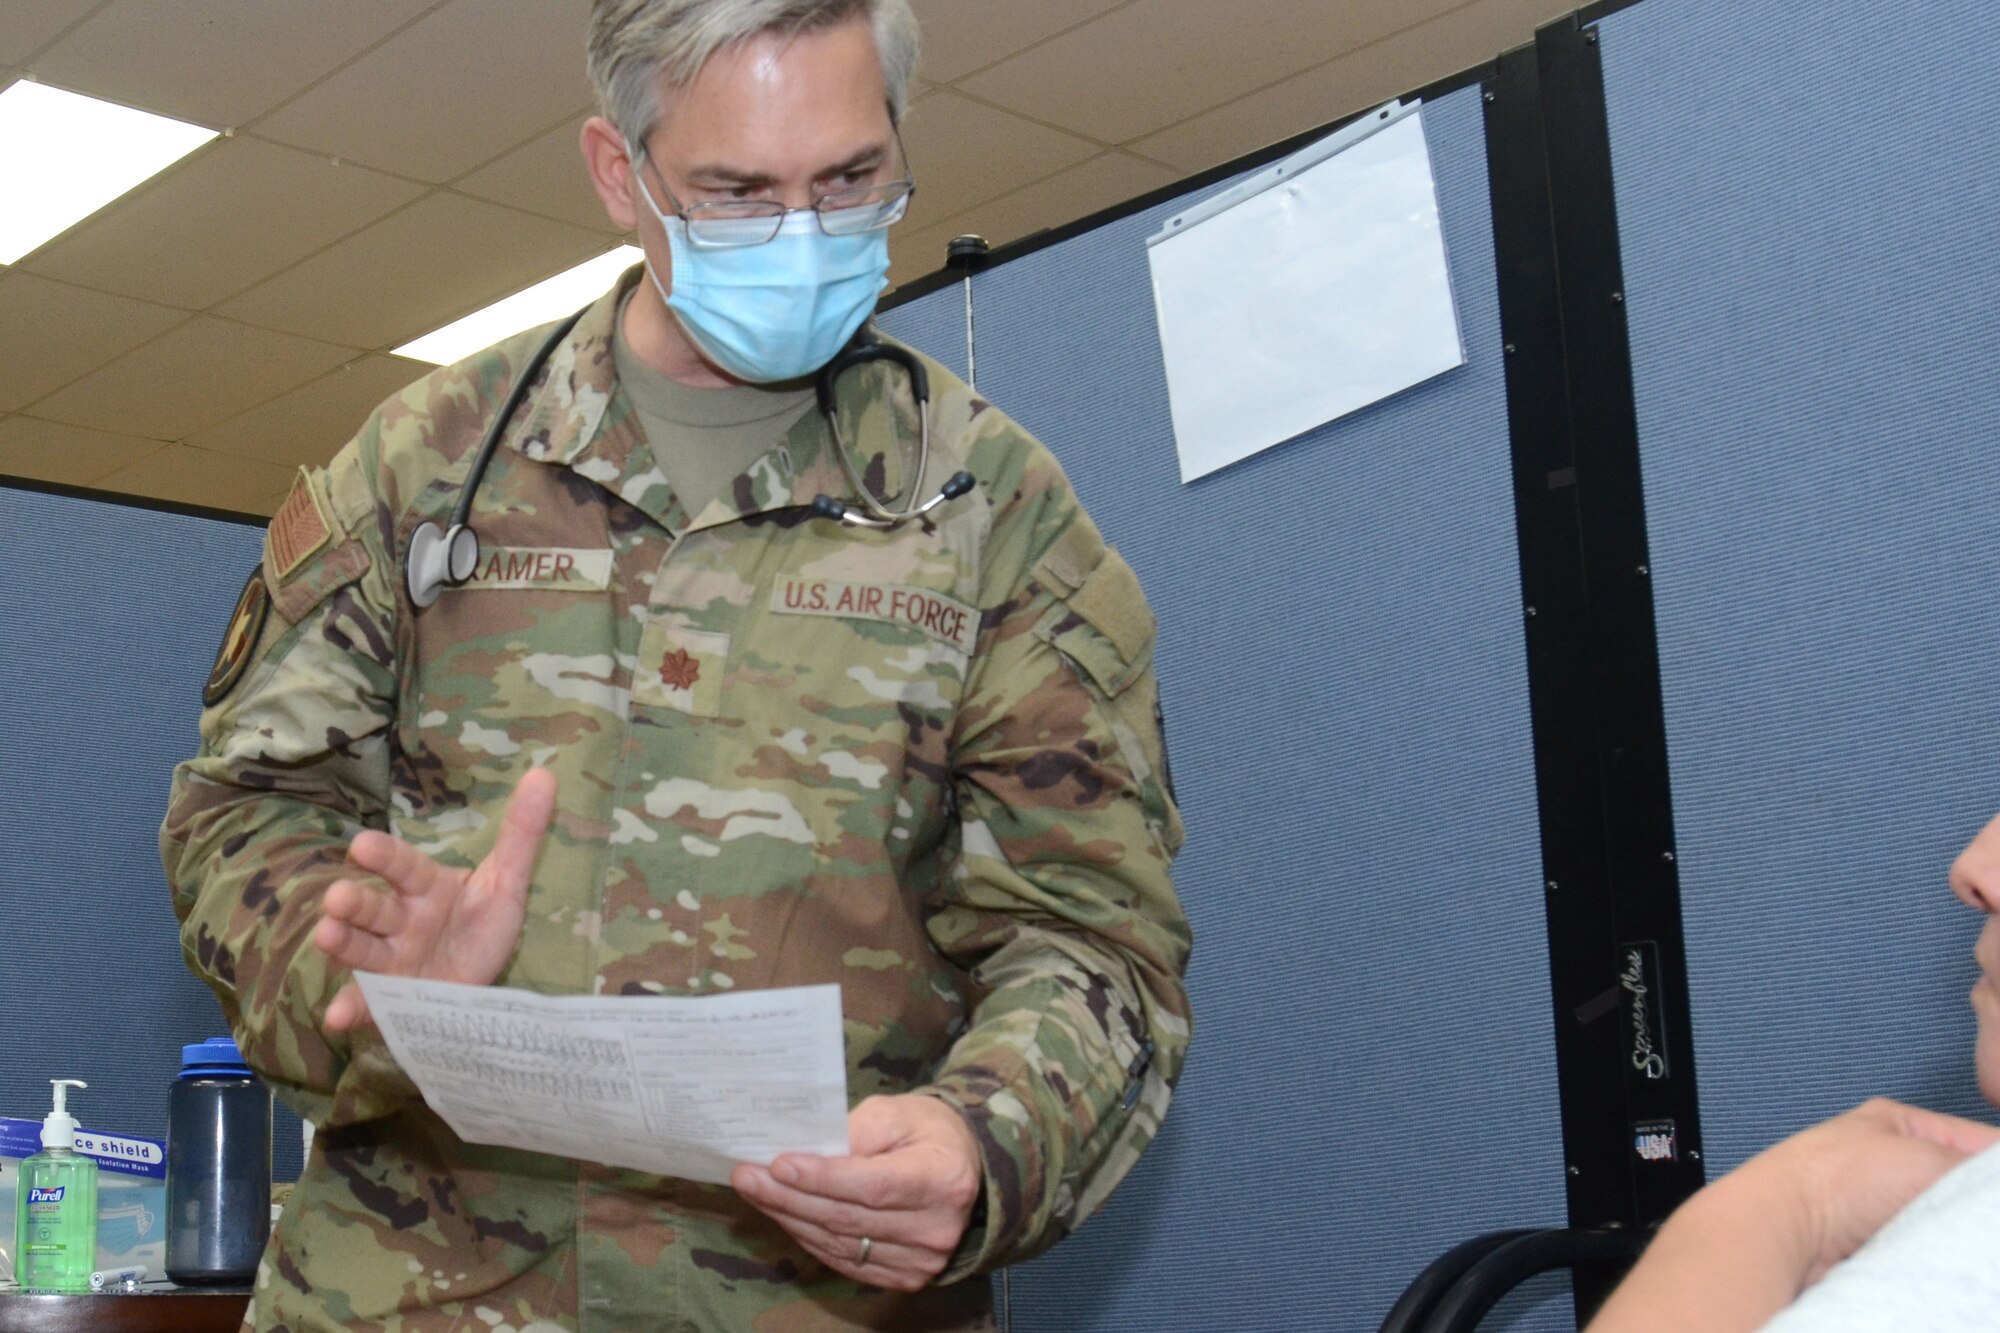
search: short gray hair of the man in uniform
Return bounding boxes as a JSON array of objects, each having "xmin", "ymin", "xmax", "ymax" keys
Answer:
[{"xmin": 588, "ymin": 0, "xmax": 918, "ymax": 142}]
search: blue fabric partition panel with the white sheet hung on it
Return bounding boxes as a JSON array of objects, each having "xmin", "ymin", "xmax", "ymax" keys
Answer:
[{"xmin": 884, "ymin": 80, "xmax": 1570, "ymax": 1333}]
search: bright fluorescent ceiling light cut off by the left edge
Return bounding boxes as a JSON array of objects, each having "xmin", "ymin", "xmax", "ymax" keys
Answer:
[{"xmin": 0, "ymin": 80, "xmax": 216, "ymax": 264}]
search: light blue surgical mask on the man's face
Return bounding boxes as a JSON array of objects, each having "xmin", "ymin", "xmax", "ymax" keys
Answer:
[{"xmin": 640, "ymin": 180, "xmax": 888, "ymax": 384}]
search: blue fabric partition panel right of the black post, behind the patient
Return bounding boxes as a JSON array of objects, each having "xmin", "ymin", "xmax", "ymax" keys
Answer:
[{"xmin": 1600, "ymin": 0, "xmax": 2000, "ymax": 1173}]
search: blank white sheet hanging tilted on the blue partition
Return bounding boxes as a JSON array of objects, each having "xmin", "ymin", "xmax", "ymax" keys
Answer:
[{"xmin": 1146, "ymin": 102, "xmax": 1466, "ymax": 482}]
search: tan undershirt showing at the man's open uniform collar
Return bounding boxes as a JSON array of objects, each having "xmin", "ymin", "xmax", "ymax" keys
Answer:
[{"xmin": 612, "ymin": 296, "xmax": 812, "ymax": 518}]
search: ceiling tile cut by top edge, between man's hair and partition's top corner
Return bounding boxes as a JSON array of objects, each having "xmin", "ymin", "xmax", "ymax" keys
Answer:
[{"xmin": 958, "ymin": 0, "xmax": 1464, "ymax": 144}]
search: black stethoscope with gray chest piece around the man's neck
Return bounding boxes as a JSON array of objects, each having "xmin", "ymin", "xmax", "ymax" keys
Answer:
[{"xmin": 402, "ymin": 306, "xmax": 974, "ymax": 608}]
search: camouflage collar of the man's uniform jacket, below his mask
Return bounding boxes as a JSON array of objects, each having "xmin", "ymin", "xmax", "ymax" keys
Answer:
[{"xmin": 506, "ymin": 264, "xmax": 918, "ymax": 534}]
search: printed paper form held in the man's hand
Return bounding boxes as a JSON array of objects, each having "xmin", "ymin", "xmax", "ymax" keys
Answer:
[{"xmin": 356, "ymin": 973, "xmax": 848, "ymax": 1185}]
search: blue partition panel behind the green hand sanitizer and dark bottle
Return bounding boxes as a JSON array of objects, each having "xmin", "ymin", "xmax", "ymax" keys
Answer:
[{"xmin": 0, "ymin": 486, "xmax": 300, "ymax": 1179}]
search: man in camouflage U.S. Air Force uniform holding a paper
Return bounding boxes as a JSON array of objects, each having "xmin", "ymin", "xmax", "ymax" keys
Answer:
[{"xmin": 162, "ymin": 0, "xmax": 1188, "ymax": 1333}]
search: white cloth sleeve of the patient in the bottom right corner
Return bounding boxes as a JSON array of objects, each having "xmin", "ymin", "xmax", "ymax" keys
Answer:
[{"xmin": 1764, "ymin": 1147, "xmax": 2000, "ymax": 1333}]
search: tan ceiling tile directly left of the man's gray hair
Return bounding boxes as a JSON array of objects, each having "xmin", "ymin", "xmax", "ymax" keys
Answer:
[{"xmin": 256, "ymin": 0, "xmax": 594, "ymax": 182}]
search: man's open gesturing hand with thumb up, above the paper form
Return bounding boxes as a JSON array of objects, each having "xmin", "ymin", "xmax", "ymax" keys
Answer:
[{"xmin": 312, "ymin": 769, "xmax": 556, "ymax": 1033}]
